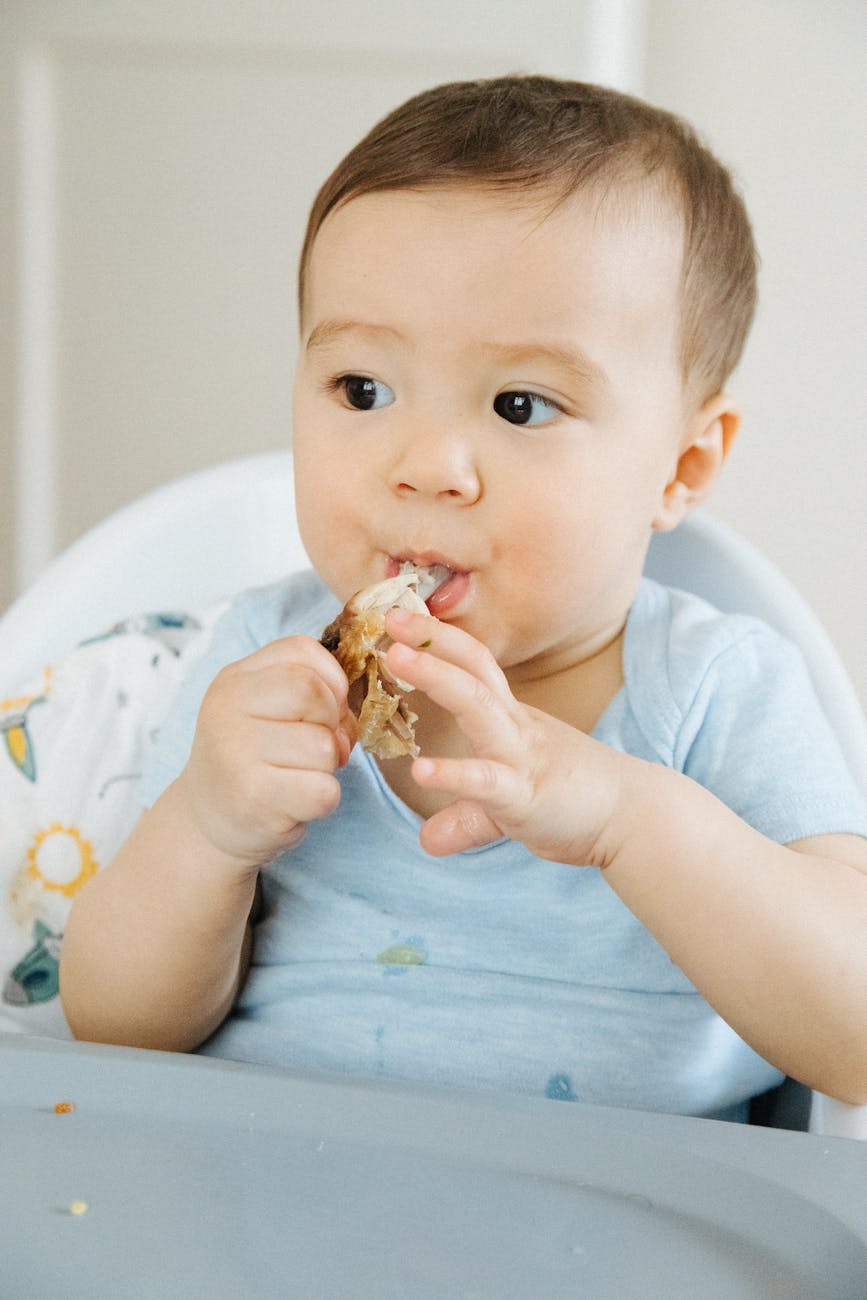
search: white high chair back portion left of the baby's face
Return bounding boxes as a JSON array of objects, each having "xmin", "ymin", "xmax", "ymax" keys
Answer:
[{"xmin": 0, "ymin": 451, "xmax": 308, "ymax": 683}]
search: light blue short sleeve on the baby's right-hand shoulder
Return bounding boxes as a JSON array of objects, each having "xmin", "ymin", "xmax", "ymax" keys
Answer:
[{"xmin": 675, "ymin": 620, "xmax": 867, "ymax": 844}]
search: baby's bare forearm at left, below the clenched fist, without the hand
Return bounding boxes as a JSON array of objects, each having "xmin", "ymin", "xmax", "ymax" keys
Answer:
[{"xmin": 60, "ymin": 780, "xmax": 256, "ymax": 1052}]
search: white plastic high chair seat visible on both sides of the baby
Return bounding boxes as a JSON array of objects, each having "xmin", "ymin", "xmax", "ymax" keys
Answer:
[{"xmin": 0, "ymin": 452, "xmax": 867, "ymax": 1140}]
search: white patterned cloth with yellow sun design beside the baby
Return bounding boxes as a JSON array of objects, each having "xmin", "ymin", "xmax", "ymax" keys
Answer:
[{"xmin": 0, "ymin": 603, "xmax": 225, "ymax": 1037}]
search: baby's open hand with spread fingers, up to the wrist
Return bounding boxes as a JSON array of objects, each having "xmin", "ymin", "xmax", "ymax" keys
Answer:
[{"xmin": 386, "ymin": 610, "xmax": 628, "ymax": 867}]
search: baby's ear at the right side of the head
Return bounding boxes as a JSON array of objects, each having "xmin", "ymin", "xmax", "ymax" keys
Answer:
[{"xmin": 651, "ymin": 393, "xmax": 741, "ymax": 533}]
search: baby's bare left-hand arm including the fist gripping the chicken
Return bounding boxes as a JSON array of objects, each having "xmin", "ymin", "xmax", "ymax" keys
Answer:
[{"xmin": 60, "ymin": 637, "xmax": 355, "ymax": 1052}]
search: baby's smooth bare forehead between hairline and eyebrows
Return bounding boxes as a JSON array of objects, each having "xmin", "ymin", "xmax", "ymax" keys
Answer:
[{"xmin": 302, "ymin": 183, "xmax": 684, "ymax": 371}]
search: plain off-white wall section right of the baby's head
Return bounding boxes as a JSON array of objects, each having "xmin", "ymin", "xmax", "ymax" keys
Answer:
[{"xmin": 646, "ymin": 0, "xmax": 867, "ymax": 706}]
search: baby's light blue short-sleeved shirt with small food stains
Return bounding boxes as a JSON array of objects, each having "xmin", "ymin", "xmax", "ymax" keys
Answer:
[{"xmin": 142, "ymin": 573, "xmax": 867, "ymax": 1117}]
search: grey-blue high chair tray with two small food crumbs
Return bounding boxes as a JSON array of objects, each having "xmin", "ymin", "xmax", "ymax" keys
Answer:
[{"xmin": 0, "ymin": 1035, "xmax": 867, "ymax": 1300}]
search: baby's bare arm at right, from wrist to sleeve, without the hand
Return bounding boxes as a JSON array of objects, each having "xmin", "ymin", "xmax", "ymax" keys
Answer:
[{"xmin": 597, "ymin": 785, "xmax": 867, "ymax": 1104}]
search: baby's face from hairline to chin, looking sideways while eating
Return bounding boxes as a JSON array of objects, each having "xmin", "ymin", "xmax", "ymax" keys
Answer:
[{"xmin": 294, "ymin": 187, "xmax": 686, "ymax": 675}]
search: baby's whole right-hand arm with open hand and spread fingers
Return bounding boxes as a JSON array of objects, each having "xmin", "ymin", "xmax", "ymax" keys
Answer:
[{"xmin": 387, "ymin": 603, "xmax": 867, "ymax": 1104}]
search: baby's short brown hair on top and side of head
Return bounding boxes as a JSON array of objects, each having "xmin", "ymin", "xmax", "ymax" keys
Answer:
[{"xmin": 299, "ymin": 77, "xmax": 758, "ymax": 399}]
